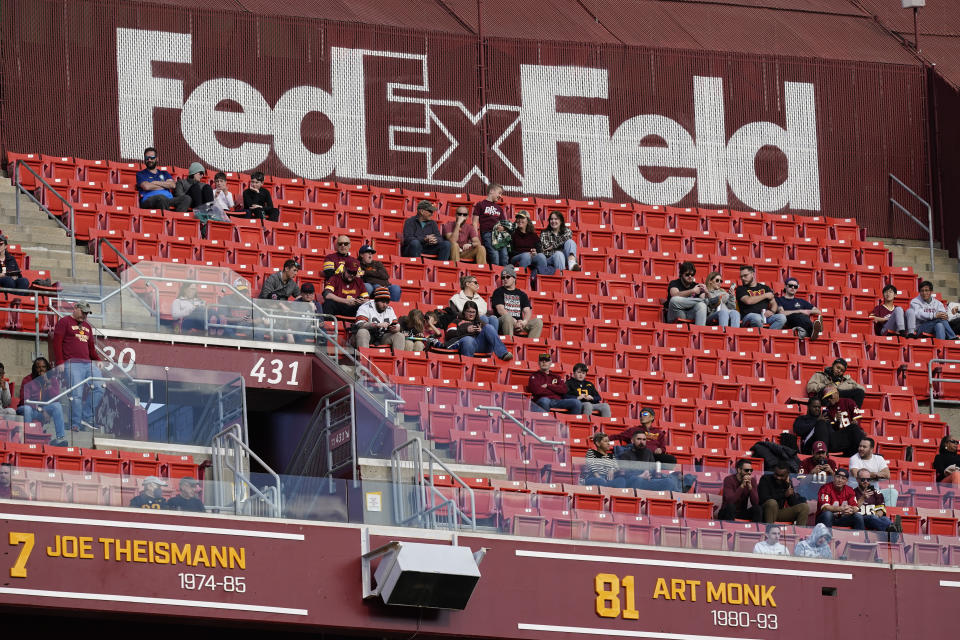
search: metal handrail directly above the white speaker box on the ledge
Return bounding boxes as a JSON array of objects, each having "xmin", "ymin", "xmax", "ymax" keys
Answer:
[{"xmin": 390, "ymin": 437, "xmax": 477, "ymax": 531}]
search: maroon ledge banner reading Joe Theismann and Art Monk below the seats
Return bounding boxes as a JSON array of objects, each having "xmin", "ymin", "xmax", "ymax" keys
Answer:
[{"xmin": 0, "ymin": 502, "xmax": 960, "ymax": 640}]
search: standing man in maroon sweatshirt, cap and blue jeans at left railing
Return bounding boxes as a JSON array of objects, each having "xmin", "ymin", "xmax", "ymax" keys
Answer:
[{"xmin": 50, "ymin": 302, "xmax": 103, "ymax": 431}]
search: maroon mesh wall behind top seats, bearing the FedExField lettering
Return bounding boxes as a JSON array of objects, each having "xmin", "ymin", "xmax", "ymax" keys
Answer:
[{"xmin": 2, "ymin": 0, "xmax": 930, "ymax": 237}]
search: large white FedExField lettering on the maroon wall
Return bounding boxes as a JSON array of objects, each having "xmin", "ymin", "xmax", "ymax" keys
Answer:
[{"xmin": 116, "ymin": 28, "xmax": 821, "ymax": 211}]
